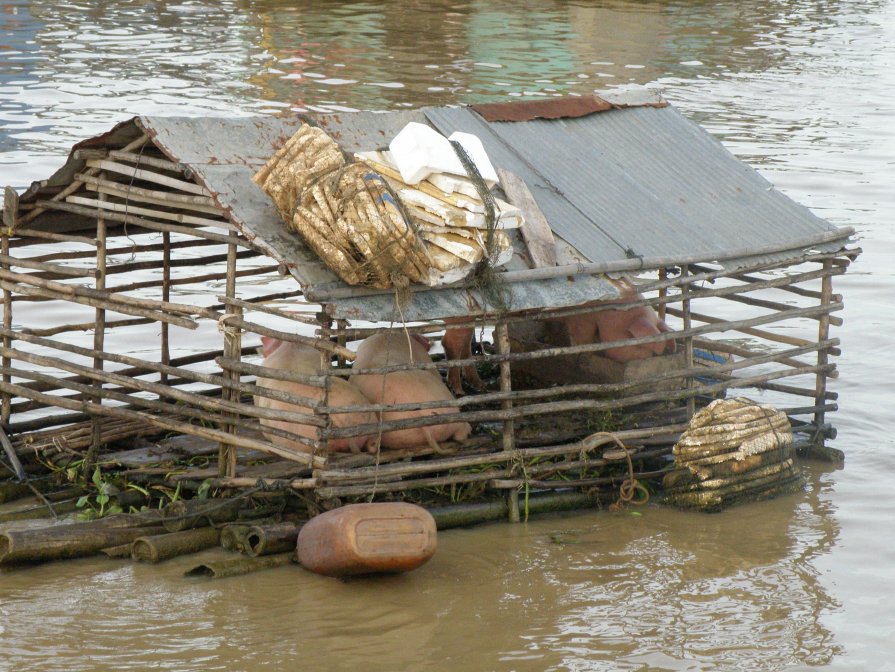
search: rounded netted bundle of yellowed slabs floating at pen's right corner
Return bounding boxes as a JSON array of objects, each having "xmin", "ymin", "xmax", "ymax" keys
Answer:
[{"xmin": 663, "ymin": 397, "xmax": 802, "ymax": 511}]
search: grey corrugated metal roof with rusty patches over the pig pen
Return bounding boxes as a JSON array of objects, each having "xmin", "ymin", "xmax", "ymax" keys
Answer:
[{"xmin": 15, "ymin": 89, "xmax": 849, "ymax": 320}]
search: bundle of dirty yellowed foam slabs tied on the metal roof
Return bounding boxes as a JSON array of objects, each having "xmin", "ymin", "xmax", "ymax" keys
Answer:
[{"xmin": 253, "ymin": 124, "xmax": 521, "ymax": 289}]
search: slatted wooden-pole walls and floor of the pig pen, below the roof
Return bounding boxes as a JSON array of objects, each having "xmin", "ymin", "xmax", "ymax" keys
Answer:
[{"xmin": 0, "ymin": 100, "xmax": 860, "ymax": 573}]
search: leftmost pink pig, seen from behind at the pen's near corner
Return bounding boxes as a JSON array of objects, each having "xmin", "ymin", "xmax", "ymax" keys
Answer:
[{"xmin": 255, "ymin": 336, "xmax": 376, "ymax": 453}]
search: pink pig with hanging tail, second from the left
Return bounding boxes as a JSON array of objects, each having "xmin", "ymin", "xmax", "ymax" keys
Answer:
[{"xmin": 349, "ymin": 333, "xmax": 472, "ymax": 448}]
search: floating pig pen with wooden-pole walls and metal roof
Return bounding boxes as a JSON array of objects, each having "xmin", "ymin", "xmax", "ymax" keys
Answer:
[{"xmin": 0, "ymin": 91, "xmax": 859, "ymax": 520}]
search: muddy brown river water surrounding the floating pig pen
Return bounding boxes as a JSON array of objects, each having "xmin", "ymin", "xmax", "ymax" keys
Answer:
[{"xmin": 0, "ymin": 0, "xmax": 895, "ymax": 671}]
